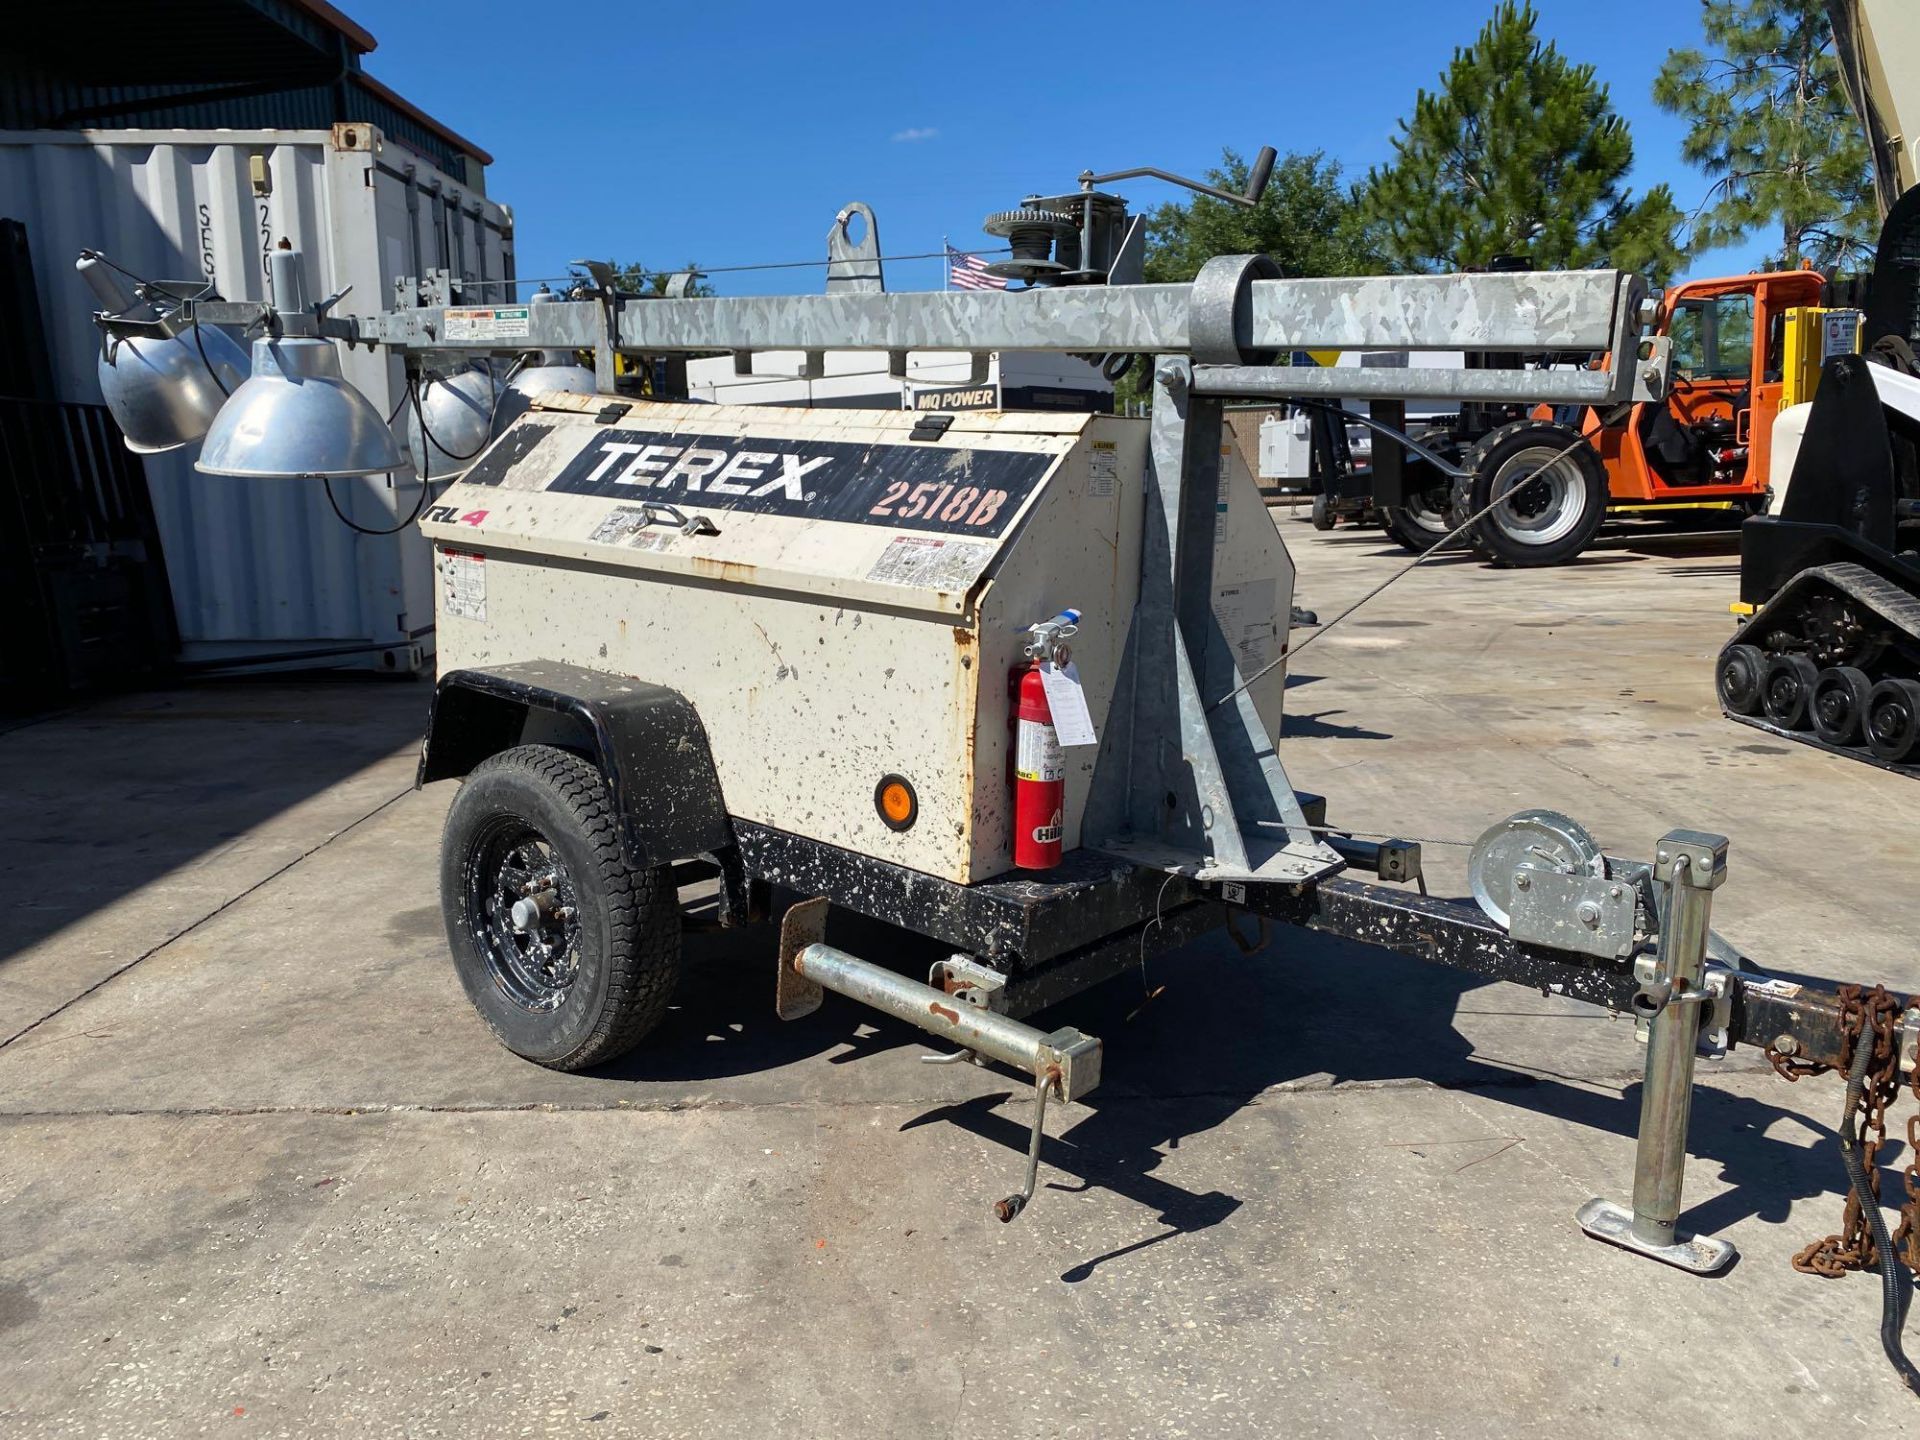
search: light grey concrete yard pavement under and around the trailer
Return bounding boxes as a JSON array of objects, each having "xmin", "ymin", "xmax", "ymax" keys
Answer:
[{"xmin": 0, "ymin": 520, "xmax": 1920, "ymax": 1440}]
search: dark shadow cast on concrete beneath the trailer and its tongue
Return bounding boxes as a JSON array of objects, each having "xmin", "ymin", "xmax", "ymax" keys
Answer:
[{"xmin": 622, "ymin": 914, "xmax": 1881, "ymax": 1283}]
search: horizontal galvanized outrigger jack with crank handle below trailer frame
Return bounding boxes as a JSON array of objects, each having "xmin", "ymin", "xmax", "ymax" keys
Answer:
[{"xmin": 774, "ymin": 895, "xmax": 1100, "ymax": 1221}]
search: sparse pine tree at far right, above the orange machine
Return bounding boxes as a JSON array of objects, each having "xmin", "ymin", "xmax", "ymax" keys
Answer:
[{"xmin": 1653, "ymin": 0, "xmax": 1878, "ymax": 269}]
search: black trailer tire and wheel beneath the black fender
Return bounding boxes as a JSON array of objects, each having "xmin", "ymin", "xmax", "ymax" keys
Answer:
[{"xmin": 440, "ymin": 745, "xmax": 680, "ymax": 1069}]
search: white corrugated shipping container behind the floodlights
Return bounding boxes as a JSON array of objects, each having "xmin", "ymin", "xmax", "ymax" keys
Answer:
[{"xmin": 0, "ymin": 125, "xmax": 513, "ymax": 670}]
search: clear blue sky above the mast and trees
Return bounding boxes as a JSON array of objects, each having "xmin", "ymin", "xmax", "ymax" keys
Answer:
[{"xmin": 344, "ymin": 0, "xmax": 1764, "ymax": 294}]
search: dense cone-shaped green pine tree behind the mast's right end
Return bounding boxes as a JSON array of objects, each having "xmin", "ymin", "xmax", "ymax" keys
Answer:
[{"xmin": 1361, "ymin": 0, "xmax": 1682, "ymax": 280}]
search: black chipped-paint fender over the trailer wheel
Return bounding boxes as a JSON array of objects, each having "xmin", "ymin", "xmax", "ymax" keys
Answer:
[{"xmin": 415, "ymin": 660, "xmax": 733, "ymax": 868}]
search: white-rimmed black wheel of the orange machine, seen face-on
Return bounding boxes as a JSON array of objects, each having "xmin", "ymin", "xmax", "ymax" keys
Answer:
[{"xmin": 1467, "ymin": 420, "xmax": 1607, "ymax": 566}]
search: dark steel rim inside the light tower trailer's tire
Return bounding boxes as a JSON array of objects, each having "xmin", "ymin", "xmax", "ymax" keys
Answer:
[{"xmin": 465, "ymin": 816, "xmax": 580, "ymax": 1016}]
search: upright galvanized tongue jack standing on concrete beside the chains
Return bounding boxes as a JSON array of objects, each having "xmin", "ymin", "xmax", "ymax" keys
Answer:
[{"xmin": 1576, "ymin": 829, "xmax": 1734, "ymax": 1275}]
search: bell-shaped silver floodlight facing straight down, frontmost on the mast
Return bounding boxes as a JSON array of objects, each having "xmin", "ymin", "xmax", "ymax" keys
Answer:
[{"xmin": 194, "ymin": 250, "xmax": 407, "ymax": 480}]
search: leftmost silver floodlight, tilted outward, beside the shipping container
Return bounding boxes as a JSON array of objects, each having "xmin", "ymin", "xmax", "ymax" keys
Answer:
[{"xmin": 75, "ymin": 252, "xmax": 248, "ymax": 455}]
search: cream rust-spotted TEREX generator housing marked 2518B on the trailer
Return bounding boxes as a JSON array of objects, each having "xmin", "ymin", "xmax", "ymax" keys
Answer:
[{"xmin": 422, "ymin": 396, "xmax": 1294, "ymax": 885}]
